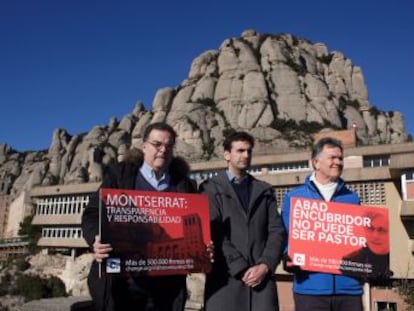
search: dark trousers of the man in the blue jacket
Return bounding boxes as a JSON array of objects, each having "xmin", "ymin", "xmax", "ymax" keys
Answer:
[{"xmin": 294, "ymin": 293, "xmax": 362, "ymax": 311}]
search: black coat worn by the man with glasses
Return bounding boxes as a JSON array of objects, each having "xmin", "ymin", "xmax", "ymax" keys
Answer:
[{"xmin": 82, "ymin": 150, "xmax": 196, "ymax": 311}]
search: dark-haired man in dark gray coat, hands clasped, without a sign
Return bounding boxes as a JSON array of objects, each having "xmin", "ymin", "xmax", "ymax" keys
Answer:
[{"xmin": 200, "ymin": 132, "xmax": 285, "ymax": 311}]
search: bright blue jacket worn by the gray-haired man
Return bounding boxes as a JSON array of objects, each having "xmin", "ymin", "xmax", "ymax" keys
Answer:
[{"xmin": 282, "ymin": 176, "xmax": 362, "ymax": 295}]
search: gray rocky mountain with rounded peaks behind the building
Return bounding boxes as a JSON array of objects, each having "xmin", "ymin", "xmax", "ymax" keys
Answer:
[{"xmin": 0, "ymin": 30, "xmax": 408, "ymax": 200}]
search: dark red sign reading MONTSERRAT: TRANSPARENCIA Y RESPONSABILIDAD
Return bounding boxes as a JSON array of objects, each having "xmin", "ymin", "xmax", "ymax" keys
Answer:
[{"xmin": 100, "ymin": 189, "xmax": 211, "ymax": 275}]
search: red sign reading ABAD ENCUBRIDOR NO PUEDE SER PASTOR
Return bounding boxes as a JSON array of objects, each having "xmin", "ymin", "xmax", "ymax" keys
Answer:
[{"xmin": 288, "ymin": 198, "xmax": 389, "ymax": 276}]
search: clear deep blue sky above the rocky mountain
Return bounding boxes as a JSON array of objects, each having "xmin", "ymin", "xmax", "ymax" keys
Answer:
[{"xmin": 0, "ymin": 0, "xmax": 414, "ymax": 151}]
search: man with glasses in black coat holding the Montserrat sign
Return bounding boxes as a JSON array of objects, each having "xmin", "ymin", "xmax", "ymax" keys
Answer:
[{"xmin": 82, "ymin": 122, "xmax": 196, "ymax": 311}]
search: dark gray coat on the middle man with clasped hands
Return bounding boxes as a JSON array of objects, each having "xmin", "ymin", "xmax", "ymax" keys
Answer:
[{"xmin": 200, "ymin": 172, "xmax": 285, "ymax": 311}]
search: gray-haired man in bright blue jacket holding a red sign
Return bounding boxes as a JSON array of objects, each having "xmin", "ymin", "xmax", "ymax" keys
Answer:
[{"xmin": 282, "ymin": 137, "xmax": 363, "ymax": 311}]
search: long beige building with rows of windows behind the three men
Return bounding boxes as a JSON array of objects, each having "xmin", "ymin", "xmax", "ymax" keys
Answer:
[{"xmin": 13, "ymin": 131, "xmax": 414, "ymax": 311}]
